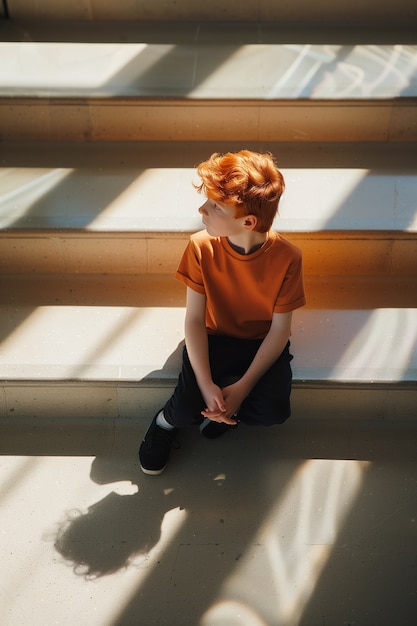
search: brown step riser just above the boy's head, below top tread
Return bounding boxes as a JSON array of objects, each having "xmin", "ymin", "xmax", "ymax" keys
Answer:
[{"xmin": 0, "ymin": 98, "xmax": 417, "ymax": 144}]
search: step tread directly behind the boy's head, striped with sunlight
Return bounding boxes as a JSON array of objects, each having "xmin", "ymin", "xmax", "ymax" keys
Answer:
[{"xmin": 0, "ymin": 140, "xmax": 417, "ymax": 232}]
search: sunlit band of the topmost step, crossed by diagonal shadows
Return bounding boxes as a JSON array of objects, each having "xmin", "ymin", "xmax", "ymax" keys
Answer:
[{"xmin": 0, "ymin": 36, "xmax": 417, "ymax": 100}]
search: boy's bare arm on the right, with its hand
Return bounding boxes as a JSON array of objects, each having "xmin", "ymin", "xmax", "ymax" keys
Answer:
[{"xmin": 203, "ymin": 312, "xmax": 292, "ymax": 422}]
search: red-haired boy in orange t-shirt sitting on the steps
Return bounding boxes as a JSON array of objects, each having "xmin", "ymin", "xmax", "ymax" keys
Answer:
[{"xmin": 139, "ymin": 150, "xmax": 305, "ymax": 474}]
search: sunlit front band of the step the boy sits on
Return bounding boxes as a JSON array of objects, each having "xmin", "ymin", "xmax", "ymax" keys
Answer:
[{"xmin": 0, "ymin": 306, "xmax": 417, "ymax": 384}]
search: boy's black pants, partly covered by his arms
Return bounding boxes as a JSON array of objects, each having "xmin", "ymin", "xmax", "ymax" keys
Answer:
[{"xmin": 164, "ymin": 335, "xmax": 293, "ymax": 428}]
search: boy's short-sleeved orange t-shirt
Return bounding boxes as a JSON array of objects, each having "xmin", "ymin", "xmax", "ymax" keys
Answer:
[{"xmin": 175, "ymin": 230, "xmax": 305, "ymax": 339}]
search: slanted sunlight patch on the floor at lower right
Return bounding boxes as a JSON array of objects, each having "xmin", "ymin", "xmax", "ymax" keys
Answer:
[{"xmin": 201, "ymin": 459, "xmax": 370, "ymax": 626}]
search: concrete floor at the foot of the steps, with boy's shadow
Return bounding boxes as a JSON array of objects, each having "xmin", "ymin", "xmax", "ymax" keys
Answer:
[{"xmin": 0, "ymin": 416, "xmax": 417, "ymax": 626}]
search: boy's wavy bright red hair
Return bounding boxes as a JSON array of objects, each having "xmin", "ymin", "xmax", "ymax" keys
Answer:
[{"xmin": 195, "ymin": 150, "xmax": 285, "ymax": 232}]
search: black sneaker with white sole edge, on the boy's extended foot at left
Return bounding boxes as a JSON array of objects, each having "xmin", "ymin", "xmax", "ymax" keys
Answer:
[{"xmin": 139, "ymin": 411, "xmax": 179, "ymax": 475}]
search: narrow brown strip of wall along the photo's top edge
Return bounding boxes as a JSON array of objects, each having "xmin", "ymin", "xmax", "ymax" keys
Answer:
[{"xmin": 8, "ymin": 0, "xmax": 417, "ymax": 23}]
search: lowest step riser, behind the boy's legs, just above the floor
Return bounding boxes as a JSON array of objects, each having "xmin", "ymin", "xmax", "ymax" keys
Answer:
[{"xmin": 0, "ymin": 378, "xmax": 417, "ymax": 420}]
